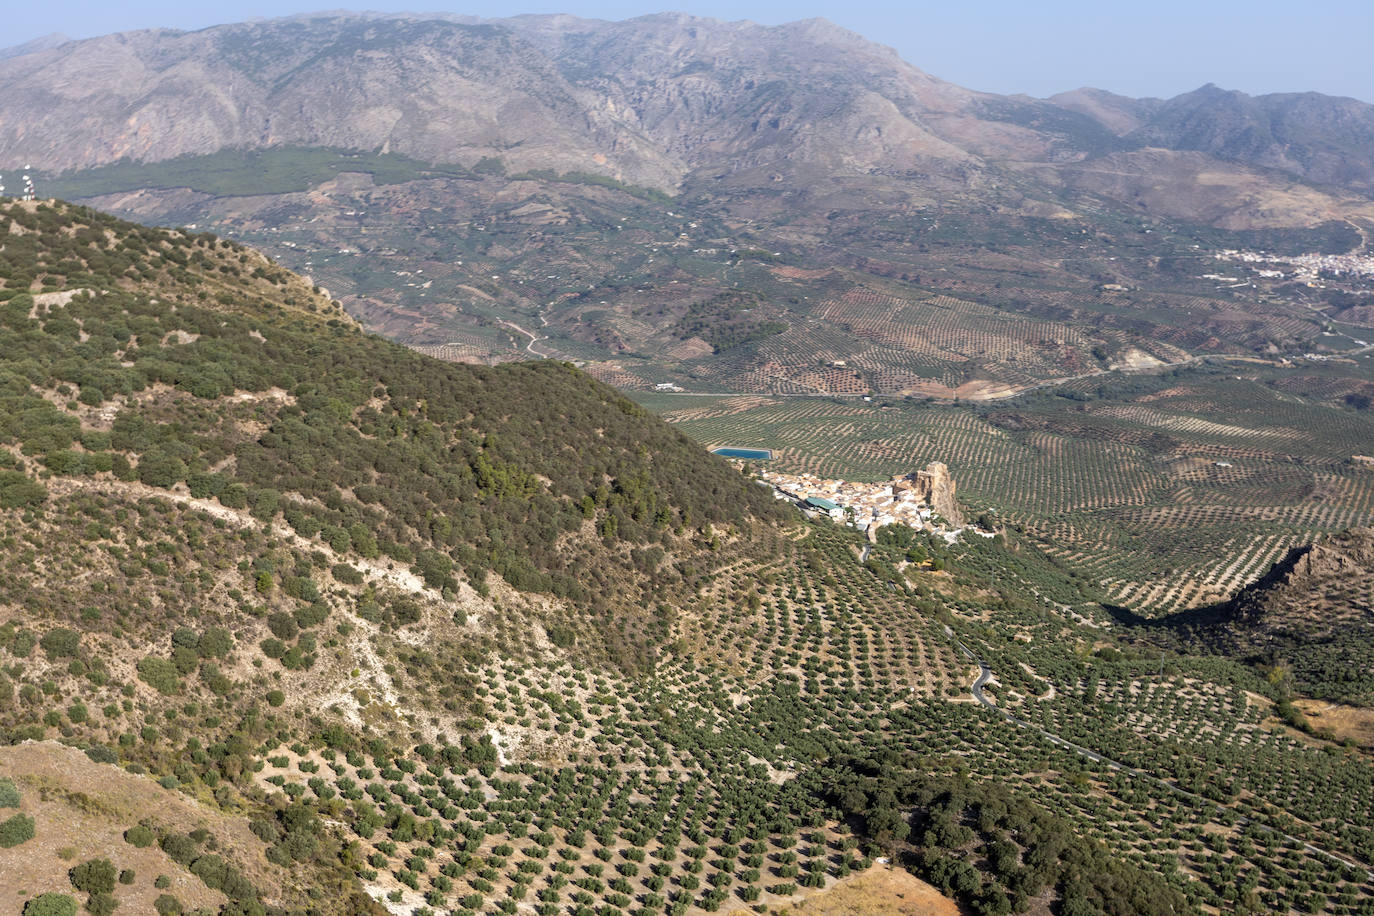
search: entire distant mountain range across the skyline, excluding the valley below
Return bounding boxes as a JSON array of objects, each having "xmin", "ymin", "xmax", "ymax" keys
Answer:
[{"xmin": 0, "ymin": 14, "xmax": 1374, "ymax": 220}]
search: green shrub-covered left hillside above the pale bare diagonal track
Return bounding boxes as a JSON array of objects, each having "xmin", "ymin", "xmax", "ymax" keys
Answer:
[{"xmin": 0, "ymin": 205, "xmax": 778, "ymax": 663}]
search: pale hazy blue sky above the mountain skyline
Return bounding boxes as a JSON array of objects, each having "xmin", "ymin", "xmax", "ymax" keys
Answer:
[{"xmin": 10, "ymin": 0, "xmax": 1374, "ymax": 102}]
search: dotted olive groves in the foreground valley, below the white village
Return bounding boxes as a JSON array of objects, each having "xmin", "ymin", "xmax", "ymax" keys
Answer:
[{"xmin": 241, "ymin": 525, "xmax": 1374, "ymax": 915}]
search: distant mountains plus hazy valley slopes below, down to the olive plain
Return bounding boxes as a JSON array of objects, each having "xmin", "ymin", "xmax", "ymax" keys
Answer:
[{"xmin": 0, "ymin": 14, "xmax": 1374, "ymax": 409}]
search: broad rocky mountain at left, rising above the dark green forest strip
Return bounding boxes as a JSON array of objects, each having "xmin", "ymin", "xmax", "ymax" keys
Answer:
[{"xmin": 0, "ymin": 16, "xmax": 680, "ymax": 184}]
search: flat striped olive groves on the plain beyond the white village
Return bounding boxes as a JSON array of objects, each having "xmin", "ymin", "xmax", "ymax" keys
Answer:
[{"xmin": 644, "ymin": 369, "xmax": 1374, "ymax": 615}]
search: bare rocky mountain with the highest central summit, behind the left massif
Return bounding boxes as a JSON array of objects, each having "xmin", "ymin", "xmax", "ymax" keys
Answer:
[{"xmin": 506, "ymin": 14, "xmax": 977, "ymax": 182}]
